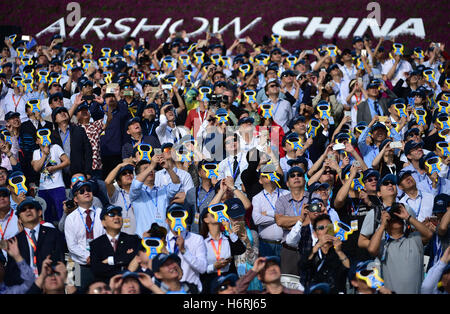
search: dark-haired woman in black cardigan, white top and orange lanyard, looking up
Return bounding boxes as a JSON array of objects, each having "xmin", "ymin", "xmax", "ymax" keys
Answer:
[{"xmin": 200, "ymin": 209, "xmax": 246, "ymax": 294}]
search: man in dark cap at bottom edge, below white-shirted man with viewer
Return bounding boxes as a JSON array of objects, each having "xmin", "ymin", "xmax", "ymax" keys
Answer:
[{"xmin": 152, "ymin": 253, "xmax": 199, "ymax": 294}]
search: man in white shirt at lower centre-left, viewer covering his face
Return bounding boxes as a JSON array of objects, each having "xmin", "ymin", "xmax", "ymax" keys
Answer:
[{"xmin": 165, "ymin": 203, "xmax": 208, "ymax": 292}]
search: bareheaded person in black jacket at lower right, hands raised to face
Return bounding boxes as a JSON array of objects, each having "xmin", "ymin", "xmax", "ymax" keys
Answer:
[{"xmin": 299, "ymin": 214, "xmax": 350, "ymax": 294}]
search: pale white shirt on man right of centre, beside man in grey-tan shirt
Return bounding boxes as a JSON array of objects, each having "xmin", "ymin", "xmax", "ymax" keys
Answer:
[{"xmin": 252, "ymin": 188, "xmax": 289, "ymax": 241}]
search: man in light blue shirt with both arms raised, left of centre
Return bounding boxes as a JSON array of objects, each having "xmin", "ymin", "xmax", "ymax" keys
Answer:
[{"xmin": 130, "ymin": 155, "xmax": 181, "ymax": 236}]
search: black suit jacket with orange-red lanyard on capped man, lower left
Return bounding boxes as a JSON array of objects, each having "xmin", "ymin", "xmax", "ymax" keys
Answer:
[{"xmin": 5, "ymin": 225, "xmax": 66, "ymax": 286}]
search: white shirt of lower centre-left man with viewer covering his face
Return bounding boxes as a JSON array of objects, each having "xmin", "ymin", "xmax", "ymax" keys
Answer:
[{"xmin": 166, "ymin": 231, "xmax": 208, "ymax": 291}]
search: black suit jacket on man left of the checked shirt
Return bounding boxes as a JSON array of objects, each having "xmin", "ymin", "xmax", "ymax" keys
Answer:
[{"xmin": 51, "ymin": 123, "xmax": 92, "ymax": 174}]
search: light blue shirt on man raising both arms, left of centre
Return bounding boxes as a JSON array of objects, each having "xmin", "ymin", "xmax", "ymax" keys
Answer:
[{"xmin": 130, "ymin": 179, "xmax": 181, "ymax": 237}]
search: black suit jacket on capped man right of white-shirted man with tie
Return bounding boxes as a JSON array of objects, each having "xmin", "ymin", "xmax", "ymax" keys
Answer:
[{"xmin": 90, "ymin": 232, "xmax": 141, "ymax": 282}]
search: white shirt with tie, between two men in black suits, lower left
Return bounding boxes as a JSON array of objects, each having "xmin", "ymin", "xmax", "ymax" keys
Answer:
[{"xmin": 64, "ymin": 207, "xmax": 105, "ymax": 265}]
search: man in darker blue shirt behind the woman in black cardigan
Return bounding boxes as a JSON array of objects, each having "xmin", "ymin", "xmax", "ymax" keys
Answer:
[{"xmin": 183, "ymin": 160, "xmax": 217, "ymax": 233}]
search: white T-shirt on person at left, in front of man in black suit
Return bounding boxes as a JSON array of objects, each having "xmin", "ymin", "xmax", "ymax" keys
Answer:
[{"xmin": 33, "ymin": 144, "xmax": 65, "ymax": 190}]
